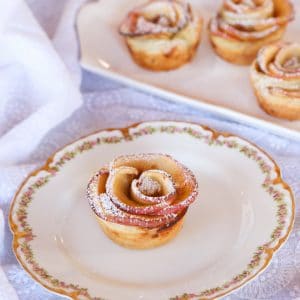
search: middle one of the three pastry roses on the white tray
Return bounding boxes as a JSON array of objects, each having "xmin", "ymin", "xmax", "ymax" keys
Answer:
[{"xmin": 209, "ymin": 0, "xmax": 293, "ymax": 64}]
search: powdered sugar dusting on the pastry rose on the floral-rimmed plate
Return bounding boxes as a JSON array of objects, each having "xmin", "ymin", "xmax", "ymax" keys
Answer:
[{"xmin": 87, "ymin": 154, "xmax": 198, "ymax": 228}]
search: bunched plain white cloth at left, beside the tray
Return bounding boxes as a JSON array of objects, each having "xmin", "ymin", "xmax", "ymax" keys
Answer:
[{"xmin": 0, "ymin": 0, "xmax": 82, "ymax": 299}]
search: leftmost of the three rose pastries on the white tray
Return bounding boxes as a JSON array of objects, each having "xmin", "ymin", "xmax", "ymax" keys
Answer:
[{"xmin": 119, "ymin": 0, "xmax": 202, "ymax": 71}]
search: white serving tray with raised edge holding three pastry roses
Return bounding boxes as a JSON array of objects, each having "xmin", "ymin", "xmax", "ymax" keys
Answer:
[{"xmin": 77, "ymin": 0, "xmax": 300, "ymax": 139}]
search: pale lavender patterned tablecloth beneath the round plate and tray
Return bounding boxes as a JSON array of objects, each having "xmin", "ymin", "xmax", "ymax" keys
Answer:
[{"xmin": 0, "ymin": 0, "xmax": 300, "ymax": 300}]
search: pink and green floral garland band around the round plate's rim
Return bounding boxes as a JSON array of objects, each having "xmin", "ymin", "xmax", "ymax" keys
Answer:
[{"xmin": 10, "ymin": 123, "xmax": 294, "ymax": 300}]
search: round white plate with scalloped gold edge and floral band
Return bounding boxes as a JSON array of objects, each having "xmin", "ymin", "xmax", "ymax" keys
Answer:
[{"xmin": 10, "ymin": 122, "xmax": 294, "ymax": 300}]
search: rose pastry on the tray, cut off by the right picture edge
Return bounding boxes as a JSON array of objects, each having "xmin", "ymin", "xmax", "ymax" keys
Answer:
[{"xmin": 250, "ymin": 43, "xmax": 300, "ymax": 120}]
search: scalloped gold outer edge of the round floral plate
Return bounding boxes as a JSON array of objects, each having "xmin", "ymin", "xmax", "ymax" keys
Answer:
[{"xmin": 8, "ymin": 120, "xmax": 295, "ymax": 299}]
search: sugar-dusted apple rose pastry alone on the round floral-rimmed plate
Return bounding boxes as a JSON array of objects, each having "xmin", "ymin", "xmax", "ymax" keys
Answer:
[{"xmin": 87, "ymin": 154, "xmax": 198, "ymax": 249}]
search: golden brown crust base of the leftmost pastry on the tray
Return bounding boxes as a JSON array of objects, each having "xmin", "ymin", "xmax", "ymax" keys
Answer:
[{"xmin": 121, "ymin": 0, "xmax": 203, "ymax": 71}]
